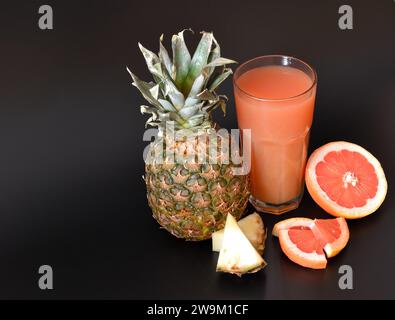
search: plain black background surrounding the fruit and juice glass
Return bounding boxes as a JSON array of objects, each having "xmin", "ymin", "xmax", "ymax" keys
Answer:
[{"xmin": 0, "ymin": 0, "xmax": 395, "ymax": 299}]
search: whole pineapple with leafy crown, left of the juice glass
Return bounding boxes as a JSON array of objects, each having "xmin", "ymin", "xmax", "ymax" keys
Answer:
[{"xmin": 127, "ymin": 30, "xmax": 249, "ymax": 240}]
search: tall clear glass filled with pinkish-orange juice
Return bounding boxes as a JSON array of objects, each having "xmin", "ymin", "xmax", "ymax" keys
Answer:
[{"xmin": 233, "ymin": 55, "xmax": 317, "ymax": 214}]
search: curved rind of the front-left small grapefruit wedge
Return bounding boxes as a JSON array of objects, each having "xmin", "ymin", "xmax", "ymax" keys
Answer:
[{"xmin": 279, "ymin": 229, "xmax": 327, "ymax": 269}]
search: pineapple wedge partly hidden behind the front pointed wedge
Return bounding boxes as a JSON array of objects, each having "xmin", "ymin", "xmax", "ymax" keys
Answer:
[{"xmin": 212, "ymin": 212, "xmax": 266, "ymax": 255}]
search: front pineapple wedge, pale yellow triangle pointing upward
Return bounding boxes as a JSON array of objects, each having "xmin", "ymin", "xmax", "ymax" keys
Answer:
[{"xmin": 217, "ymin": 214, "xmax": 266, "ymax": 276}]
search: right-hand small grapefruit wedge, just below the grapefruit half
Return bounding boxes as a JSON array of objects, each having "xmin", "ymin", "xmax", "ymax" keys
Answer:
[{"xmin": 310, "ymin": 218, "xmax": 350, "ymax": 258}]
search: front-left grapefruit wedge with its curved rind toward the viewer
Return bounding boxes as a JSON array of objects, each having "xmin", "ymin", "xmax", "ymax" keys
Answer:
[{"xmin": 278, "ymin": 227, "xmax": 327, "ymax": 269}]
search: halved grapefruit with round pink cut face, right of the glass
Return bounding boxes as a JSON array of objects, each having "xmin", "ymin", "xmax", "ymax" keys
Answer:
[{"xmin": 306, "ymin": 141, "xmax": 387, "ymax": 219}]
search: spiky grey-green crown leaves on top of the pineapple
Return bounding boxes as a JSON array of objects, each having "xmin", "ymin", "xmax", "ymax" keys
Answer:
[{"xmin": 126, "ymin": 30, "xmax": 236, "ymax": 129}]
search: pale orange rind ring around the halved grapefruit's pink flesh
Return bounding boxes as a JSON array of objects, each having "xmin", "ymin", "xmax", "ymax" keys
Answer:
[{"xmin": 306, "ymin": 141, "xmax": 388, "ymax": 219}]
